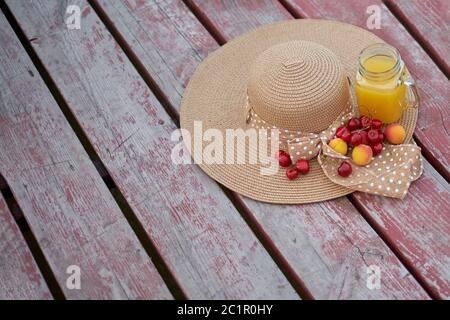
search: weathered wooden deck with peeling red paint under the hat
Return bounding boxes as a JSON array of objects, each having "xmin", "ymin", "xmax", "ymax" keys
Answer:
[{"xmin": 0, "ymin": 0, "xmax": 450, "ymax": 299}]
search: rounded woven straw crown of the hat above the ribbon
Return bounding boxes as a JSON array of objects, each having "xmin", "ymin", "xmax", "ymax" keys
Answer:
[{"xmin": 248, "ymin": 41, "xmax": 350, "ymax": 132}]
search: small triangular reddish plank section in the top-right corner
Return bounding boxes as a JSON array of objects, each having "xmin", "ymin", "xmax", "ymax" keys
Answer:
[{"xmin": 385, "ymin": 0, "xmax": 450, "ymax": 77}]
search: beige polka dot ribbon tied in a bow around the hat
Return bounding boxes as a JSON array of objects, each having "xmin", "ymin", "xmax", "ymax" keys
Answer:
[{"xmin": 247, "ymin": 99, "xmax": 423, "ymax": 199}]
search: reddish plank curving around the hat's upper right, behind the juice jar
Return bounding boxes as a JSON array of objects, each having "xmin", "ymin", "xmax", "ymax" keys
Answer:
[{"xmin": 283, "ymin": 0, "xmax": 450, "ymax": 181}]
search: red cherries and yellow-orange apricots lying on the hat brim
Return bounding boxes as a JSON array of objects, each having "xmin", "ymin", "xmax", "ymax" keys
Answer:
[{"xmin": 276, "ymin": 116, "xmax": 406, "ymax": 180}]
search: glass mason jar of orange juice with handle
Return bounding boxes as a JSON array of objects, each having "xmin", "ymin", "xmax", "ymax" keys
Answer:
[{"xmin": 355, "ymin": 43, "xmax": 418, "ymax": 123}]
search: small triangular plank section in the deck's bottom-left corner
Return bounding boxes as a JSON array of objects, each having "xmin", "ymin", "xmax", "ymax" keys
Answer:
[{"xmin": 0, "ymin": 194, "xmax": 52, "ymax": 300}]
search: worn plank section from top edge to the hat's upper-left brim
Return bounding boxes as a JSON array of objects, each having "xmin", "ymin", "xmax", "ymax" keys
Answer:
[{"xmin": 93, "ymin": 0, "xmax": 218, "ymax": 111}]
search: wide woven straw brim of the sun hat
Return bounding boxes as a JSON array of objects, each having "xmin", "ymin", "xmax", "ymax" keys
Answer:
[{"xmin": 180, "ymin": 19, "xmax": 418, "ymax": 204}]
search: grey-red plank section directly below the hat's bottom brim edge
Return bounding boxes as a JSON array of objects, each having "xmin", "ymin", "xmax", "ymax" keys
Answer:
[{"xmin": 244, "ymin": 198, "xmax": 429, "ymax": 300}]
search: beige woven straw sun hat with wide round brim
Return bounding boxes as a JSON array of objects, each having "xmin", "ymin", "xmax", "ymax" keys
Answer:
[{"xmin": 181, "ymin": 19, "xmax": 420, "ymax": 204}]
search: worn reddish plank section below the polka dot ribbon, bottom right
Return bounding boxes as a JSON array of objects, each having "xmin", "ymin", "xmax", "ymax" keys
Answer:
[{"xmin": 352, "ymin": 162, "xmax": 450, "ymax": 299}]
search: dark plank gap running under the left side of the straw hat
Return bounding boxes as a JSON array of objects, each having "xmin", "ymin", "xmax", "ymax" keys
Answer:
[{"xmin": 87, "ymin": 0, "xmax": 314, "ymax": 300}]
